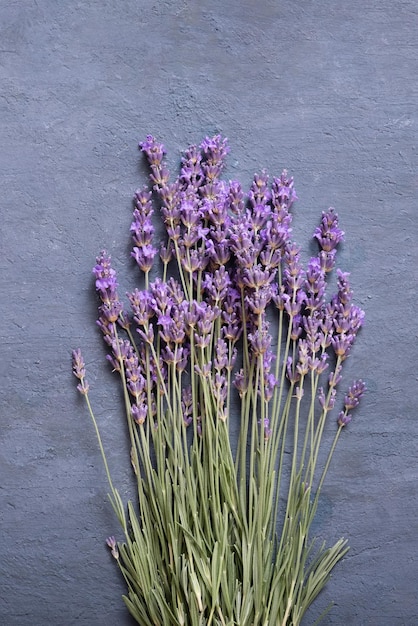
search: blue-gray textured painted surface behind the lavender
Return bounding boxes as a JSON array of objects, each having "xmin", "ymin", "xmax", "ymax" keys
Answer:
[{"xmin": 0, "ymin": 0, "xmax": 418, "ymax": 626}]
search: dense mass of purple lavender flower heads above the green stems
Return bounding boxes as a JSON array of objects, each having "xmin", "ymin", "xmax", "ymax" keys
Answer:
[{"xmin": 83, "ymin": 135, "xmax": 364, "ymax": 437}]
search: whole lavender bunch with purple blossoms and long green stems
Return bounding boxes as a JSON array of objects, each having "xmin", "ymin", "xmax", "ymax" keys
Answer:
[{"xmin": 73, "ymin": 136, "xmax": 365, "ymax": 626}]
